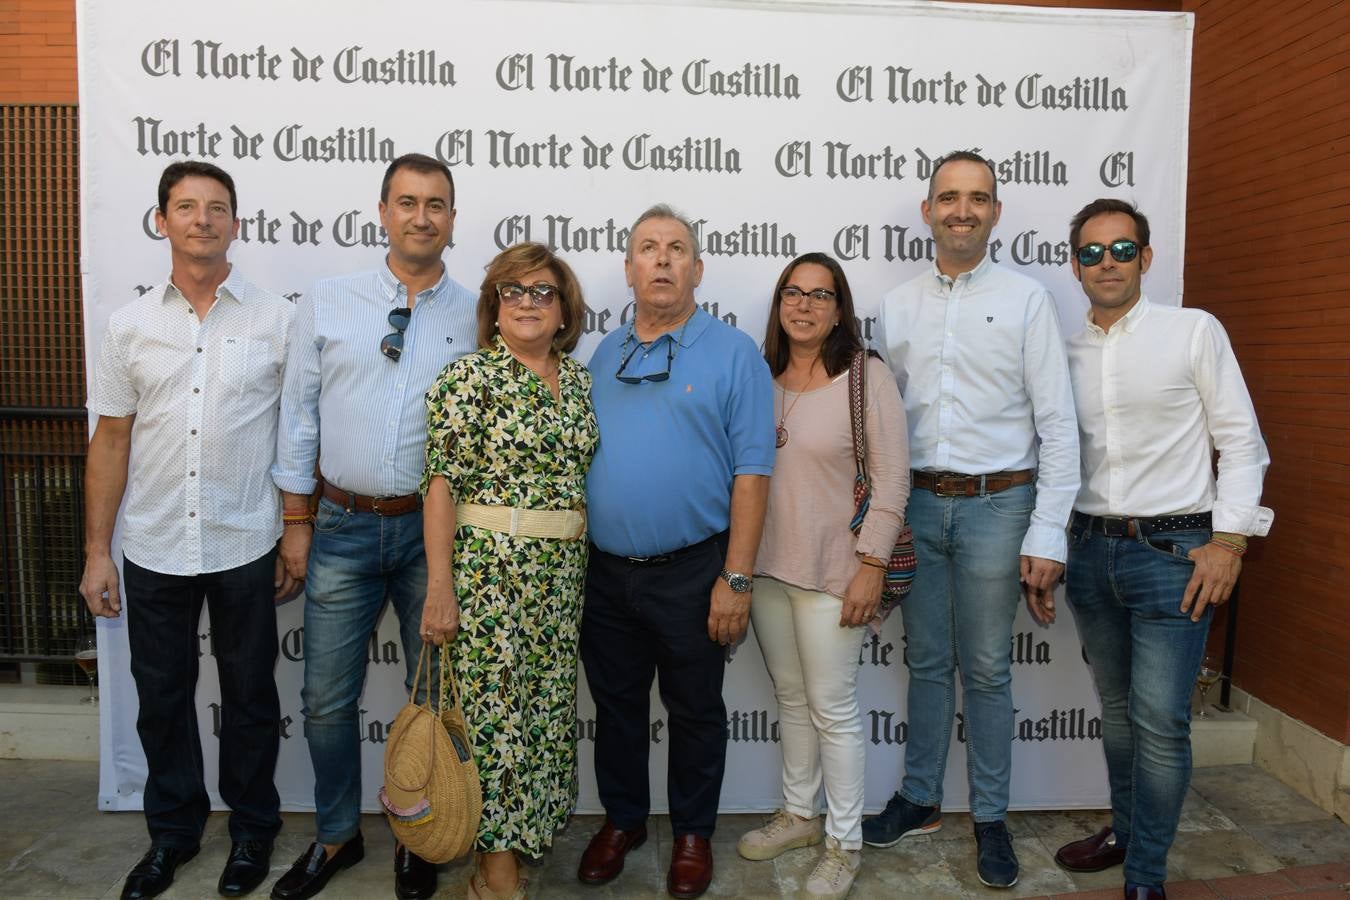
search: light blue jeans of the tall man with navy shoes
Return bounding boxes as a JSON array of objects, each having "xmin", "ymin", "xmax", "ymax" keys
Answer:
[{"xmin": 900, "ymin": 484, "xmax": 1035, "ymax": 822}]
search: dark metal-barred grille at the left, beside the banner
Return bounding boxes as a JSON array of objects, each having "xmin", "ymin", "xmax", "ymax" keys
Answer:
[{"xmin": 0, "ymin": 104, "xmax": 93, "ymax": 684}]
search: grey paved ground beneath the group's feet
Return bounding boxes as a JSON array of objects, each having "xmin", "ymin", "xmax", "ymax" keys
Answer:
[{"xmin": 0, "ymin": 760, "xmax": 1350, "ymax": 900}]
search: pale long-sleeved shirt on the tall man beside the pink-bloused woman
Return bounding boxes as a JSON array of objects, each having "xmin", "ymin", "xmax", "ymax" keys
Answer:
[{"xmin": 878, "ymin": 255, "xmax": 1079, "ymax": 563}]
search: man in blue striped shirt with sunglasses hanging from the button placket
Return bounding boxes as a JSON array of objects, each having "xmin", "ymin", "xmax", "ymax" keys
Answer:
[{"xmin": 271, "ymin": 154, "xmax": 477, "ymax": 900}]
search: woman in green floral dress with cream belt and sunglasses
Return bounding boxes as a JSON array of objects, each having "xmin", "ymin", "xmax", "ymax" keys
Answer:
[{"xmin": 421, "ymin": 243, "xmax": 598, "ymax": 900}]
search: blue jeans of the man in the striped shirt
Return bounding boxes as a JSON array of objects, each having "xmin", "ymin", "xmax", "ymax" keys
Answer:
[{"xmin": 301, "ymin": 498, "xmax": 439, "ymax": 843}]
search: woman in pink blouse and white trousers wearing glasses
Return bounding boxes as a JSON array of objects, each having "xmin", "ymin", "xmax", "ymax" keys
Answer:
[{"xmin": 737, "ymin": 254, "xmax": 910, "ymax": 897}]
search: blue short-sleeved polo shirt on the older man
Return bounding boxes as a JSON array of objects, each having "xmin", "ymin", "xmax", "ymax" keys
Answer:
[{"xmin": 586, "ymin": 309, "xmax": 775, "ymax": 556}]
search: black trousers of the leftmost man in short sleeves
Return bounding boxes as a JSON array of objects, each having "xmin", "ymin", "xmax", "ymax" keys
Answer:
[{"xmin": 122, "ymin": 551, "xmax": 281, "ymax": 847}]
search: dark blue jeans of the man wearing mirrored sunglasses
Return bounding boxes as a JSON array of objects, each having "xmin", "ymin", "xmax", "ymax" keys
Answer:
[{"xmin": 1067, "ymin": 517, "xmax": 1211, "ymax": 885}]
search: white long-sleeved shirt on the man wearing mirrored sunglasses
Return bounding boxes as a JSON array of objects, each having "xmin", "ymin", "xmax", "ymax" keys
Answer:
[{"xmin": 1069, "ymin": 297, "xmax": 1274, "ymax": 536}]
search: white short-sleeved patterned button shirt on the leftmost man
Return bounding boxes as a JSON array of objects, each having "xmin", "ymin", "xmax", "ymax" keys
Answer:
[{"xmin": 89, "ymin": 267, "xmax": 293, "ymax": 575}]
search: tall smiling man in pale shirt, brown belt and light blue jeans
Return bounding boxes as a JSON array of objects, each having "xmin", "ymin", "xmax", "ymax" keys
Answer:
[{"xmin": 863, "ymin": 151, "xmax": 1079, "ymax": 888}]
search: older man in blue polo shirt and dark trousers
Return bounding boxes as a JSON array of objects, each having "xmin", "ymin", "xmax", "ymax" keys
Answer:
[{"xmin": 576, "ymin": 205, "xmax": 774, "ymax": 897}]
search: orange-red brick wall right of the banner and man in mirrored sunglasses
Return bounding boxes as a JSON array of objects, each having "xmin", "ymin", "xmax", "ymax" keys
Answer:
[{"xmin": 1183, "ymin": 0, "xmax": 1350, "ymax": 743}]
